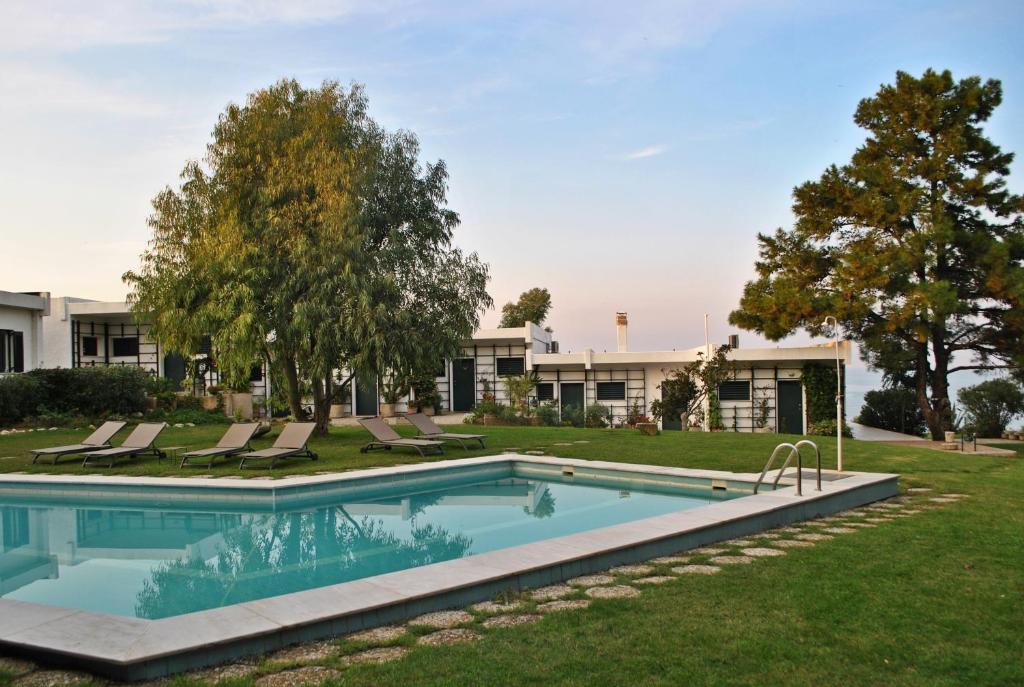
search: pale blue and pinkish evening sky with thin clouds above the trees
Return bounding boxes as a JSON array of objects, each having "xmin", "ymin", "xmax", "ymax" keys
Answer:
[{"xmin": 0, "ymin": 0, "xmax": 1024, "ymax": 409}]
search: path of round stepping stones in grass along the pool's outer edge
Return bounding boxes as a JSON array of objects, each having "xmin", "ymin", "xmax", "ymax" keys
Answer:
[{"xmin": 6, "ymin": 487, "xmax": 968, "ymax": 687}]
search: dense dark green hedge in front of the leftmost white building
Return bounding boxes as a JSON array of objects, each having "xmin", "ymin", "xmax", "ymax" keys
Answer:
[{"xmin": 0, "ymin": 367, "xmax": 150, "ymax": 424}]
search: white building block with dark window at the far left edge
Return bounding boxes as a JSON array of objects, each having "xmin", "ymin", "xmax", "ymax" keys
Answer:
[{"xmin": 0, "ymin": 291, "xmax": 50, "ymax": 375}]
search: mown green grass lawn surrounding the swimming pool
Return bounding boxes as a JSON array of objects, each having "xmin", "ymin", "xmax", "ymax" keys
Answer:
[{"xmin": 0, "ymin": 427, "xmax": 1024, "ymax": 686}]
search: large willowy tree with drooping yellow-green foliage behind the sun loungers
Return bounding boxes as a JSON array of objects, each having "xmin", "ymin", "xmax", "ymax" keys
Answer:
[{"xmin": 124, "ymin": 80, "xmax": 492, "ymax": 432}]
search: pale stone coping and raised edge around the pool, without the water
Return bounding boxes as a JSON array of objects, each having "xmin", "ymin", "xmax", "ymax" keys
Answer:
[{"xmin": 0, "ymin": 454, "xmax": 898, "ymax": 680}]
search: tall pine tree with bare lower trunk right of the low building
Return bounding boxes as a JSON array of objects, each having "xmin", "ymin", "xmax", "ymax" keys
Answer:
[{"xmin": 729, "ymin": 70, "xmax": 1024, "ymax": 438}]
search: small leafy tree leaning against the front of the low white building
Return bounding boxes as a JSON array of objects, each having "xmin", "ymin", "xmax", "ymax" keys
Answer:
[{"xmin": 650, "ymin": 346, "xmax": 733, "ymax": 430}]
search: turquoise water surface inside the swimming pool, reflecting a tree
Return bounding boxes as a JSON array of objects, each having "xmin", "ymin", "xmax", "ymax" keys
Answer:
[{"xmin": 0, "ymin": 477, "xmax": 719, "ymax": 618}]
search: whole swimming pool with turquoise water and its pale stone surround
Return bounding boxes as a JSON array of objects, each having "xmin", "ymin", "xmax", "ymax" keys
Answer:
[{"xmin": 0, "ymin": 455, "xmax": 898, "ymax": 680}]
